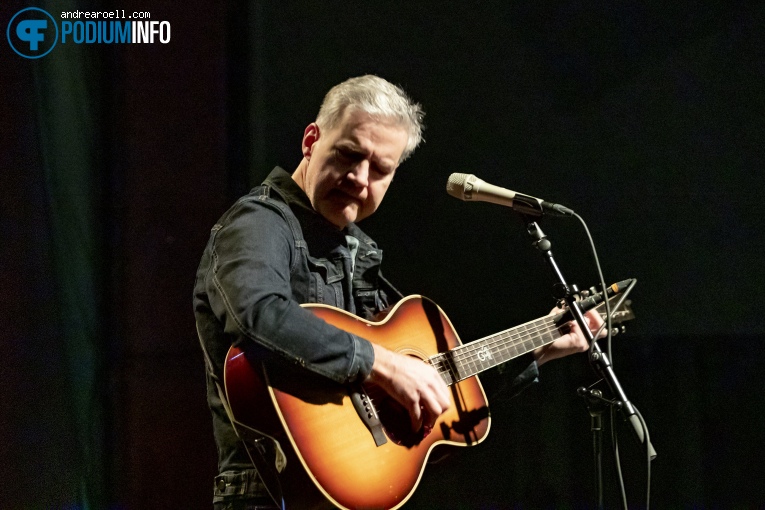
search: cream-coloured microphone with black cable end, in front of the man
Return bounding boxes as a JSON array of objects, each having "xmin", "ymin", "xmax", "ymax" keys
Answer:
[{"xmin": 446, "ymin": 174, "xmax": 574, "ymax": 216}]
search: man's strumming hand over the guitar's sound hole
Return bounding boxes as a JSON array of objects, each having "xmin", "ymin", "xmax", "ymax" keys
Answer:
[{"xmin": 369, "ymin": 344, "xmax": 450, "ymax": 435}]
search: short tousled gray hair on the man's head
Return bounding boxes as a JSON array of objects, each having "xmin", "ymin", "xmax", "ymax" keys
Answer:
[{"xmin": 316, "ymin": 74, "xmax": 425, "ymax": 161}]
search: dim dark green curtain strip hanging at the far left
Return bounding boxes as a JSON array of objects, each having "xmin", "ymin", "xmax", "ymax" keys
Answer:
[{"xmin": 35, "ymin": 2, "xmax": 109, "ymax": 509}]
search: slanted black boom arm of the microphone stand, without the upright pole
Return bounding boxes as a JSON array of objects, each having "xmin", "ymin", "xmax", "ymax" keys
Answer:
[{"xmin": 526, "ymin": 218, "xmax": 656, "ymax": 458}]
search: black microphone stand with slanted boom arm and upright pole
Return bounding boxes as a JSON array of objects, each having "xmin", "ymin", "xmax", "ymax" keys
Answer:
[{"xmin": 522, "ymin": 220, "xmax": 656, "ymax": 509}]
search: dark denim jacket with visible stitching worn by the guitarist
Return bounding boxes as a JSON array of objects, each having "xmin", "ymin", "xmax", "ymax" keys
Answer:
[{"xmin": 194, "ymin": 168, "xmax": 388, "ymax": 499}]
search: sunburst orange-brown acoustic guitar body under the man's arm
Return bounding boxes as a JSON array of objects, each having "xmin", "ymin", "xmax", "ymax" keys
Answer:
[{"xmin": 225, "ymin": 296, "xmax": 490, "ymax": 509}]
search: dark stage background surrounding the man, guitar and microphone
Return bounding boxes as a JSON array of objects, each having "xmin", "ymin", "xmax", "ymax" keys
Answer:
[{"xmin": 0, "ymin": 0, "xmax": 765, "ymax": 509}]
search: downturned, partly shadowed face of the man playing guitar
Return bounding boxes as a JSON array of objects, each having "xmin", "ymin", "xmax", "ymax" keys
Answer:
[{"xmin": 298, "ymin": 110, "xmax": 407, "ymax": 228}]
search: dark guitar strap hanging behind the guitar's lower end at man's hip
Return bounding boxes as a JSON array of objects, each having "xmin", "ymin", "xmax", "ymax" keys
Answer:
[{"xmin": 197, "ymin": 325, "xmax": 287, "ymax": 510}]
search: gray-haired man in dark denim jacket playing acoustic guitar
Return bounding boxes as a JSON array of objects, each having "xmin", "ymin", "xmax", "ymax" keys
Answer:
[{"xmin": 194, "ymin": 76, "xmax": 587, "ymax": 510}]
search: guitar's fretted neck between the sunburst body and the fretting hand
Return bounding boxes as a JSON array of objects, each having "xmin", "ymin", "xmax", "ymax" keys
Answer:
[{"xmin": 428, "ymin": 314, "xmax": 562, "ymax": 385}]
